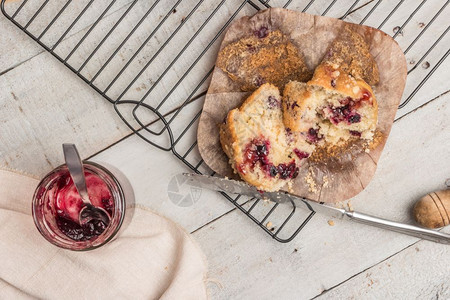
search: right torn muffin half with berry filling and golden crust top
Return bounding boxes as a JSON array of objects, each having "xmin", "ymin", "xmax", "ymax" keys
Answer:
[{"xmin": 283, "ymin": 65, "xmax": 378, "ymax": 145}]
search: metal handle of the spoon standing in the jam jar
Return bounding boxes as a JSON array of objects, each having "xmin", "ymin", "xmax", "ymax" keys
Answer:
[{"xmin": 63, "ymin": 144, "xmax": 91, "ymax": 204}]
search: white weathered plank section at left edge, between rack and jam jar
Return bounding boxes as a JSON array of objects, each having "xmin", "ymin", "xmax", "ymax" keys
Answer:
[{"xmin": 0, "ymin": 54, "xmax": 129, "ymax": 176}]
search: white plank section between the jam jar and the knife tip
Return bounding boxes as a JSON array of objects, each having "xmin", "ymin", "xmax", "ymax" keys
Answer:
[{"xmin": 92, "ymin": 136, "xmax": 239, "ymax": 231}]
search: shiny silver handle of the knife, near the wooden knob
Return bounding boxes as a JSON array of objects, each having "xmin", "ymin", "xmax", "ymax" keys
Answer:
[{"xmin": 345, "ymin": 211, "xmax": 450, "ymax": 244}]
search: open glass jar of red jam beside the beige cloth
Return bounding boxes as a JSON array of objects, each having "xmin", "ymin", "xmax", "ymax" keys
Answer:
[{"xmin": 32, "ymin": 162, "xmax": 125, "ymax": 251}]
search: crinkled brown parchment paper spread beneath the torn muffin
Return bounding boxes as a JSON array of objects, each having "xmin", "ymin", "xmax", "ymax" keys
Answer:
[{"xmin": 198, "ymin": 8, "xmax": 406, "ymax": 202}]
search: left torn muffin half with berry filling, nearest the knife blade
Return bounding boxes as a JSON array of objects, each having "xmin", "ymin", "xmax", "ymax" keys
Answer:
[{"xmin": 220, "ymin": 83, "xmax": 314, "ymax": 191}]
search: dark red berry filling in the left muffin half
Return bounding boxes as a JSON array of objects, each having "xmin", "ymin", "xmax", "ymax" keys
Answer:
[{"xmin": 237, "ymin": 139, "xmax": 298, "ymax": 179}]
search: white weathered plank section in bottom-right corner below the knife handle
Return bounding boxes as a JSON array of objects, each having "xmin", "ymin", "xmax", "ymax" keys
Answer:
[{"xmin": 318, "ymin": 233, "xmax": 450, "ymax": 299}]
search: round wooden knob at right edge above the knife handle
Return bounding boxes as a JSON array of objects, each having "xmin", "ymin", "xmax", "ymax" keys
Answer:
[{"xmin": 413, "ymin": 189, "xmax": 450, "ymax": 228}]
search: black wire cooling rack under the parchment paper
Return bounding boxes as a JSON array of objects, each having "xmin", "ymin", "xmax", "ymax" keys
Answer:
[{"xmin": 1, "ymin": 0, "xmax": 450, "ymax": 242}]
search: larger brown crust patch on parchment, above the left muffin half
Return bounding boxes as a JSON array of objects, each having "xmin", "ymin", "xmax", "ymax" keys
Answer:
[{"xmin": 216, "ymin": 27, "xmax": 312, "ymax": 91}]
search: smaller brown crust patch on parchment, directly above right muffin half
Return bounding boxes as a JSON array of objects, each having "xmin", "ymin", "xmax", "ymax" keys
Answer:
[{"xmin": 321, "ymin": 26, "xmax": 380, "ymax": 86}]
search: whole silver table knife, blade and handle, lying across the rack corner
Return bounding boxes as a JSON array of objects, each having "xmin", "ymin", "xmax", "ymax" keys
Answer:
[{"xmin": 183, "ymin": 173, "xmax": 450, "ymax": 244}]
